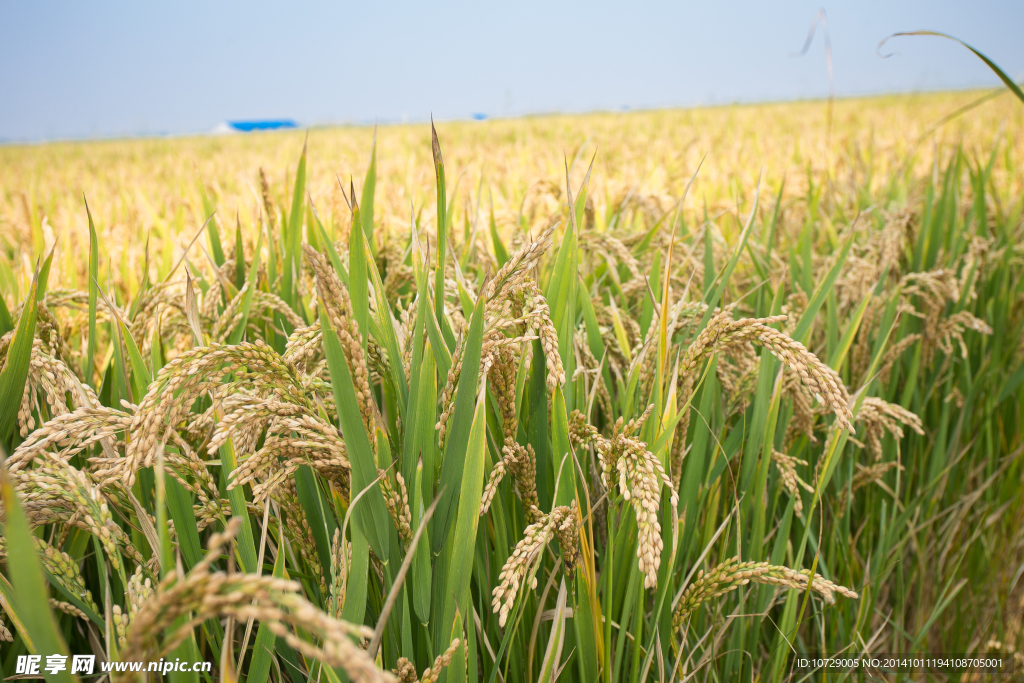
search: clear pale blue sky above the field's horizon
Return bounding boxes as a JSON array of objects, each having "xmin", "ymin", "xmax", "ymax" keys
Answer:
[{"xmin": 0, "ymin": 0, "xmax": 1024, "ymax": 141}]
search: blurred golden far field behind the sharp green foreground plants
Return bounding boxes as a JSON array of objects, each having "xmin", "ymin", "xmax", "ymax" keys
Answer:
[{"xmin": 0, "ymin": 91, "xmax": 1024, "ymax": 292}]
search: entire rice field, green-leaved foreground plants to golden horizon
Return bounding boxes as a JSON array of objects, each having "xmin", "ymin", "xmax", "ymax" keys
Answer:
[{"xmin": 0, "ymin": 92, "xmax": 1024, "ymax": 683}]
